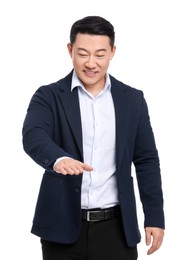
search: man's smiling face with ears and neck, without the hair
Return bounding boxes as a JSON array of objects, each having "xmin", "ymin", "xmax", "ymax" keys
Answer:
[{"xmin": 67, "ymin": 33, "xmax": 116, "ymax": 91}]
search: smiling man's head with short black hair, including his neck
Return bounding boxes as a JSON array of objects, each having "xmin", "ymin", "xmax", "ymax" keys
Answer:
[{"xmin": 67, "ymin": 16, "xmax": 116, "ymax": 94}]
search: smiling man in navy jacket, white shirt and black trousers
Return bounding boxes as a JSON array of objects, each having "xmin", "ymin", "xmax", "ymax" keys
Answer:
[{"xmin": 23, "ymin": 16, "xmax": 164, "ymax": 260}]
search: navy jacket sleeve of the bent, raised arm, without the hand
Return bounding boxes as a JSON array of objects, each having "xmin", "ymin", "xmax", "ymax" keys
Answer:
[{"xmin": 22, "ymin": 86, "xmax": 72, "ymax": 170}]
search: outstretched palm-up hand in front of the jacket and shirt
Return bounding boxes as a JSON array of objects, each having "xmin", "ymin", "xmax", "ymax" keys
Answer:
[{"xmin": 54, "ymin": 158, "xmax": 93, "ymax": 175}]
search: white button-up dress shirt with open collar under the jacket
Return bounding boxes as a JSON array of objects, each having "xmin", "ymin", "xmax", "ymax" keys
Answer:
[{"xmin": 71, "ymin": 71, "xmax": 118, "ymax": 209}]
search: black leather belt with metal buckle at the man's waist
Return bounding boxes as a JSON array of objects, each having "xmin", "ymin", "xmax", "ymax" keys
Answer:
[{"xmin": 81, "ymin": 206, "xmax": 120, "ymax": 221}]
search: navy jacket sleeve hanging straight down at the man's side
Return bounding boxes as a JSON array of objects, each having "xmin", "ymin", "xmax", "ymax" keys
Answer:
[{"xmin": 133, "ymin": 94, "xmax": 164, "ymax": 228}]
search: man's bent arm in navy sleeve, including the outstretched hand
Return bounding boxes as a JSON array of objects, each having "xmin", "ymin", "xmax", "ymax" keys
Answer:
[{"xmin": 22, "ymin": 87, "xmax": 92, "ymax": 175}]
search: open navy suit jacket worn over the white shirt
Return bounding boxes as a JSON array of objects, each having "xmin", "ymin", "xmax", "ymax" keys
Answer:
[{"xmin": 23, "ymin": 71, "xmax": 164, "ymax": 246}]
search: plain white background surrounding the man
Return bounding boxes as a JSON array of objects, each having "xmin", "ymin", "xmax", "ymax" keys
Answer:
[{"xmin": 0, "ymin": 0, "xmax": 189, "ymax": 260}]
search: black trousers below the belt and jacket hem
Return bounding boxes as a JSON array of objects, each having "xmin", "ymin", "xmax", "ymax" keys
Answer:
[{"xmin": 41, "ymin": 216, "xmax": 138, "ymax": 260}]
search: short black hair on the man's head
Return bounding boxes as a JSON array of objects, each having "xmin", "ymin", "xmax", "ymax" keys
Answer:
[{"xmin": 70, "ymin": 16, "xmax": 115, "ymax": 47}]
